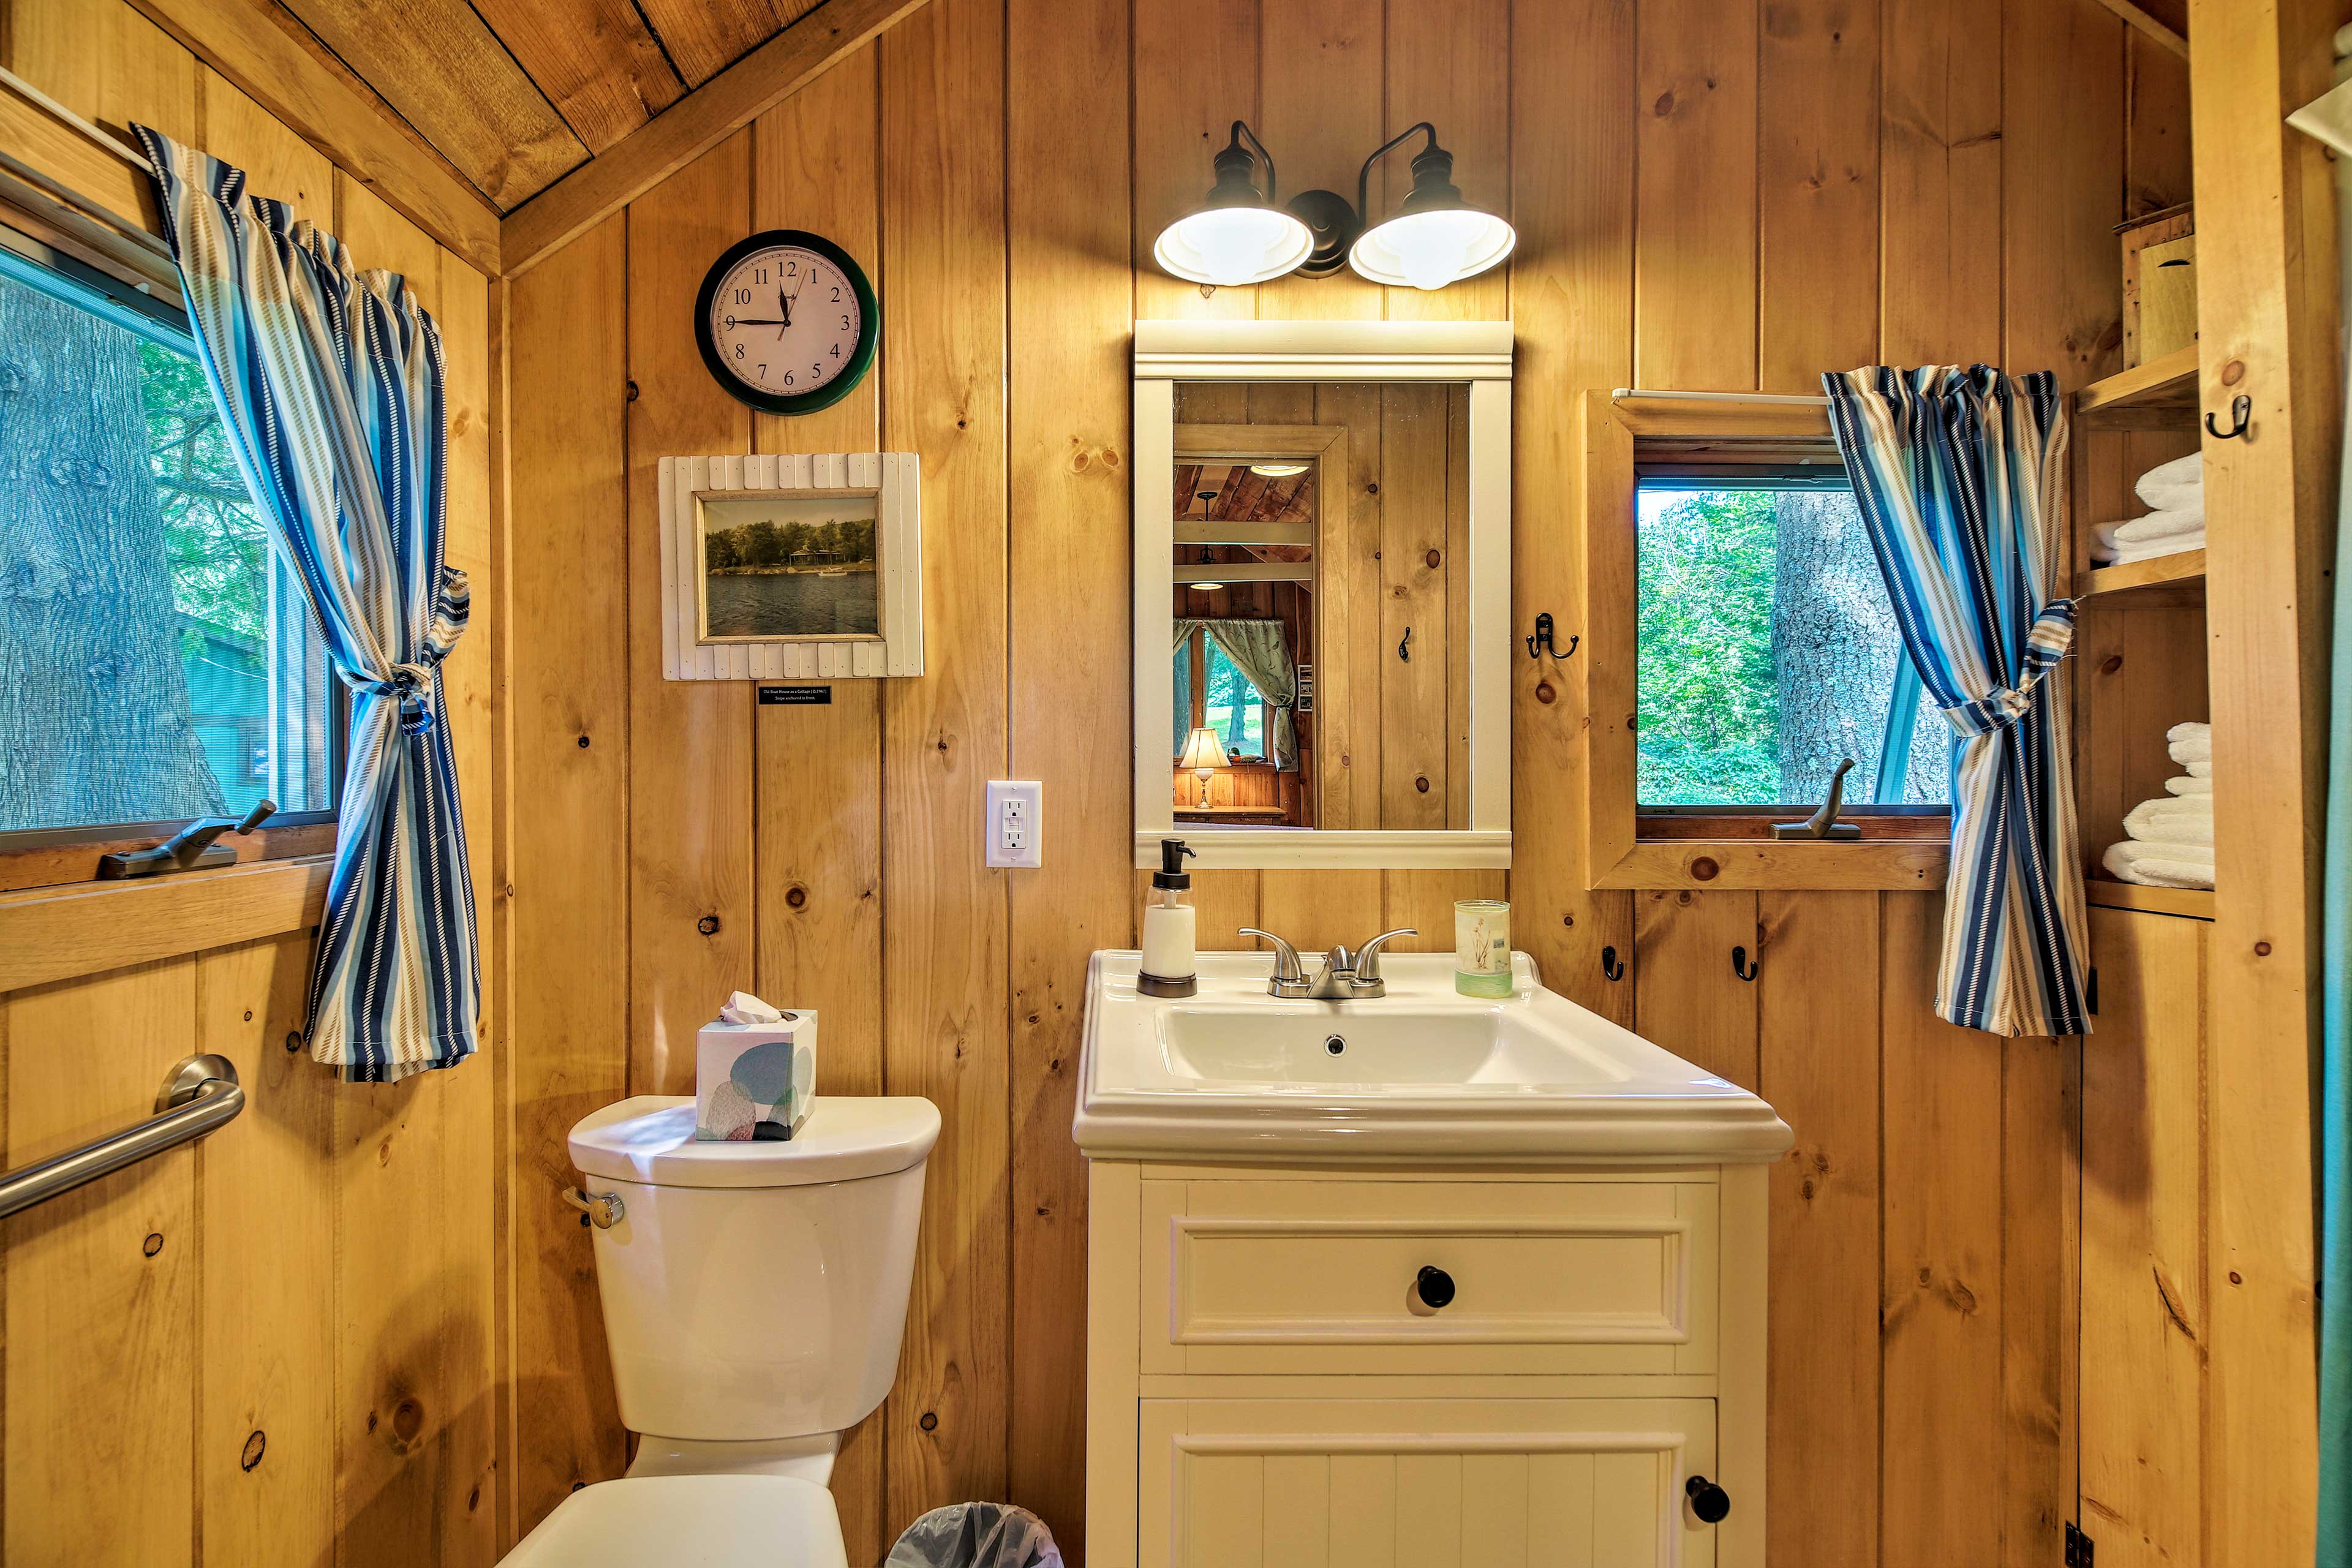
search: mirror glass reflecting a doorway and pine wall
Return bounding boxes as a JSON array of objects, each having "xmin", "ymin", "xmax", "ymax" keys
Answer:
[{"xmin": 1169, "ymin": 383, "xmax": 1470, "ymax": 832}]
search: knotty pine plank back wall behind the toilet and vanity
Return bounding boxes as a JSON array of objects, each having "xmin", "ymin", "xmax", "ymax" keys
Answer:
[{"xmin": 508, "ymin": 0, "xmax": 2185, "ymax": 1568}]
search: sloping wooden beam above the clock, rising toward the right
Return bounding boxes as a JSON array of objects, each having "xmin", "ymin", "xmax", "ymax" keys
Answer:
[{"xmin": 499, "ymin": 0, "xmax": 924, "ymax": 277}]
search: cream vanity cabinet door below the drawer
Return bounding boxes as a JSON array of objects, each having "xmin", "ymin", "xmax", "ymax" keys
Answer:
[{"xmin": 1136, "ymin": 1399, "xmax": 1738, "ymax": 1568}]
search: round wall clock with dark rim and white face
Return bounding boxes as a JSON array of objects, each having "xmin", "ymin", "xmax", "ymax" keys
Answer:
[{"xmin": 694, "ymin": 228, "xmax": 882, "ymax": 414}]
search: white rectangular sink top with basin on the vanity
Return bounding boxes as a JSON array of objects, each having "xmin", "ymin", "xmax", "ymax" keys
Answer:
[{"xmin": 1075, "ymin": 952, "xmax": 1790, "ymax": 1164}]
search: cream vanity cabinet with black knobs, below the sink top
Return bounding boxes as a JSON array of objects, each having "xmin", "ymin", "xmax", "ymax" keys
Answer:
[{"xmin": 1087, "ymin": 1159, "xmax": 1764, "ymax": 1568}]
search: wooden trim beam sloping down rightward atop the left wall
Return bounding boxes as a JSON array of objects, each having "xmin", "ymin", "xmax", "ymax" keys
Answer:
[{"xmin": 132, "ymin": 0, "xmax": 499, "ymax": 277}]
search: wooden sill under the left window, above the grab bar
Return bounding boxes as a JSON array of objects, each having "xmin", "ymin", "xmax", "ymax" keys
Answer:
[{"xmin": 0, "ymin": 856, "xmax": 334, "ymax": 992}]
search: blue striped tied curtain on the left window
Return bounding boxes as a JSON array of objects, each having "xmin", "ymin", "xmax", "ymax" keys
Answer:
[{"xmin": 132, "ymin": 124, "xmax": 480, "ymax": 1084}]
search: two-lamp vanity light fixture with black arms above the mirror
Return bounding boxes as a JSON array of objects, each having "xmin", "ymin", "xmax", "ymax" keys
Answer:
[{"xmin": 1153, "ymin": 120, "xmax": 1520, "ymax": 289}]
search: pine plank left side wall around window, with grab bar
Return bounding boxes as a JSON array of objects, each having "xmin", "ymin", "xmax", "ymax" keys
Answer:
[{"xmin": 0, "ymin": 0, "xmax": 503, "ymax": 1568}]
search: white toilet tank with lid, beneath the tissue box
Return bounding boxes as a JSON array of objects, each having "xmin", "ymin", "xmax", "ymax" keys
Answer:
[{"xmin": 571, "ymin": 1096, "xmax": 938, "ymax": 1441}]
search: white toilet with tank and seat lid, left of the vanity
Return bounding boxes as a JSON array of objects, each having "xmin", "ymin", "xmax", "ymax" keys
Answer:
[{"xmin": 503, "ymin": 1096, "xmax": 938, "ymax": 1568}]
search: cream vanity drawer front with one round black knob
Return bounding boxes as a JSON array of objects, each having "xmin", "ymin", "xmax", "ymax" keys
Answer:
[{"xmin": 1139, "ymin": 1180, "xmax": 1717, "ymax": 1373}]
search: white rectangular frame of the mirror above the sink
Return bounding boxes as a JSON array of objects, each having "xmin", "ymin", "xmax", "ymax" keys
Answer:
[{"xmin": 1134, "ymin": 322, "xmax": 1512, "ymax": 870}]
